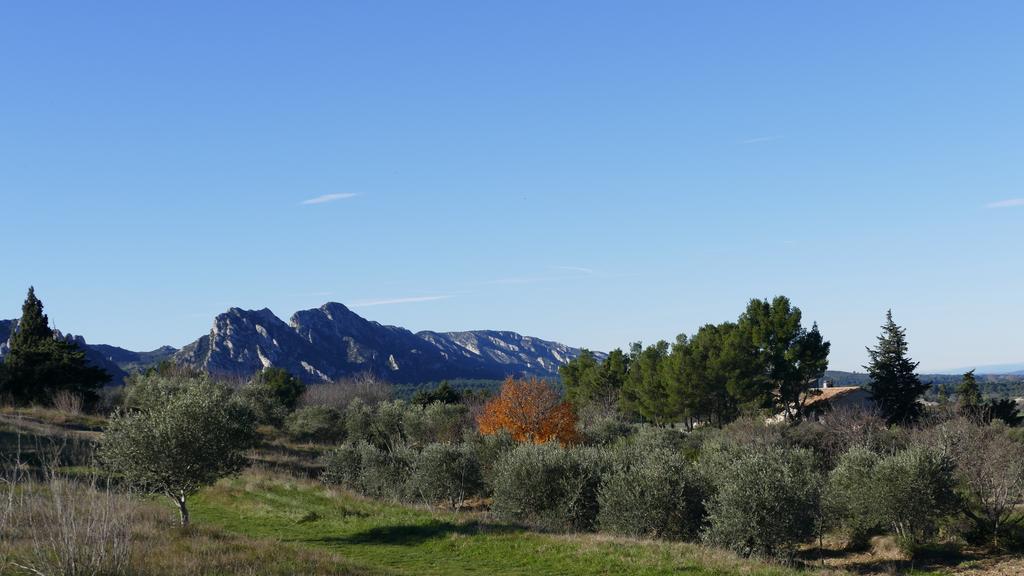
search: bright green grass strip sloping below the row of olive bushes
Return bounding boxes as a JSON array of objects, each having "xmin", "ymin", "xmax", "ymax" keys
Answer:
[{"xmin": 193, "ymin": 475, "xmax": 827, "ymax": 576}]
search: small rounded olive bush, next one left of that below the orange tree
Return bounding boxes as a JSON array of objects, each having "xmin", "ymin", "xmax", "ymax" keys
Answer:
[{"xmin": 413, "ymin": 443, "xmax": 483, "ymax": 509}]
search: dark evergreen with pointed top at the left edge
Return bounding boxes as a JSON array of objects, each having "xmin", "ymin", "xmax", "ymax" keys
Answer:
[{"xmin": 0, "ymin": 287, "xmax": 111, "ymax": 405}]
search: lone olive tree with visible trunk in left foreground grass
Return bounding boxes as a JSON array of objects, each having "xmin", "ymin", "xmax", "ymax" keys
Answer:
[{"xmin": 99, "ymin": 379, "xmax": 256, "ymax": 526}]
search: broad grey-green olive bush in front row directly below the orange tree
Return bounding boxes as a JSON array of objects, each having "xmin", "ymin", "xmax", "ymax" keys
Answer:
[{"xmin": 493, "ymin": 444, "xmax": 605, "ymax": 531}]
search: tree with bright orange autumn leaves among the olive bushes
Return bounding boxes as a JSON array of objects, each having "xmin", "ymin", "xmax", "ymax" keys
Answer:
[{"xmin": 476, "ymin": 376, "xmax": 577, "ymax": 444}]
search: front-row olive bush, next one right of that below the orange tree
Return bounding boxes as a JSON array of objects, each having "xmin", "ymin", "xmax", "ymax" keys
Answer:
[{"xmin": 598, "ymin": 447, "xmax": 708, "ymax": 539}]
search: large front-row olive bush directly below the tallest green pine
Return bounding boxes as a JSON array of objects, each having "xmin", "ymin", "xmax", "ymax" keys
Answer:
[{"xmin": 706, "ymin": 445, "xmax": 820, "ymax": 558}]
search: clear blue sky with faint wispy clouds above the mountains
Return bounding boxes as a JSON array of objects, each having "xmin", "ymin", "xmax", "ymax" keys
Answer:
[{"xmin": 0, "ymin": 0, "xmax": 1024, "ymax": 370}]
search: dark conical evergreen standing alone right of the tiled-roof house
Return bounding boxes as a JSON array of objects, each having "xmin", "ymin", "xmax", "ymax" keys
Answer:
[{"xmin": 864, "ymin": 311, "xmax": 929, "ymax": 424}]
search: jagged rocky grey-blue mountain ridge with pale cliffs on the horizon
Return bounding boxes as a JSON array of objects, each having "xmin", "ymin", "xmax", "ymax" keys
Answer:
[{"xmin": 174, "ymin": 302, "xmax": 593, "ymax": 383}]
